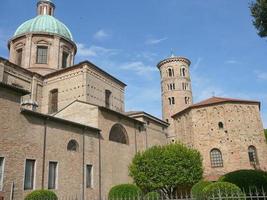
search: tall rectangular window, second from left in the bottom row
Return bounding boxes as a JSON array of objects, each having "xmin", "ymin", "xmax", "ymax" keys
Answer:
[{"xmin": 24, "ymin": 160, "xmax": 35, "ymax": 190}]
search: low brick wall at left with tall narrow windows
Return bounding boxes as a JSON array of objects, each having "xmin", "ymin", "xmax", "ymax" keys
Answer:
[{"xmin": 0, "ymin": 88, "xmax": 100, "ymax": 200}]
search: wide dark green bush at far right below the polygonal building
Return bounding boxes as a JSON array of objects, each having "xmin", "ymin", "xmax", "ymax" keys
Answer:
[{"xmin": 219, "ymin": 170, "xmax": 267, "ymax": 193}]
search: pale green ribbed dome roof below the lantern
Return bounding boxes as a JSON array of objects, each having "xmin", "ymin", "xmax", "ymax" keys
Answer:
[{"xmin": 14, "ymin": 15, "xmax": 73, "ymax": 41}]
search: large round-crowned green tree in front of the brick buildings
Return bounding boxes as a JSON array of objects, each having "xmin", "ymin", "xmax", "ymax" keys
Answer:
[{"xmin": 129, "ymin": 143, "xmax": 203, "ymax": 197}]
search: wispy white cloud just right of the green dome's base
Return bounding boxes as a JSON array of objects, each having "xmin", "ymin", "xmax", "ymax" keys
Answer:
[{"xmin": 77, "ymin": 43, "xmax": 119, "ymax": 57}]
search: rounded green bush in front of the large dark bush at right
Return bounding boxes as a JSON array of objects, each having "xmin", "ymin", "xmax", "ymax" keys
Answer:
[{"xmin": 203, "ymin": 182, "xmax": 244, "ymax": 200}]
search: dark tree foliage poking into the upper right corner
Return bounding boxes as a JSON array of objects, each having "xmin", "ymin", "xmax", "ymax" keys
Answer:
[{"xmin": 250, "ymin": 0, "xmax": 267, "ymax": 37}]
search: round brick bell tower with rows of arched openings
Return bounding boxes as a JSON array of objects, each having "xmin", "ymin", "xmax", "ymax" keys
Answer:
[{"xmin": 157, "ymin": 55, "xmax": 192, "ymax": 137}]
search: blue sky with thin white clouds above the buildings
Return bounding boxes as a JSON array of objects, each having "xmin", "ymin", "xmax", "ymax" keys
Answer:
[{"xmin": 0, "ymin": 0, "xmax": 267, "ymax": 127}]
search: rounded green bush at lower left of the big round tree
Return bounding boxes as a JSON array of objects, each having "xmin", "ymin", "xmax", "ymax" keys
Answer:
[{"xmin": 108, "ymin": 184, "xmax": 142, "ymax": 200}]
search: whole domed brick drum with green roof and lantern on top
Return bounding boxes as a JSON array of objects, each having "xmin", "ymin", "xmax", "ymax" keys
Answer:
[{"xmin": 8, "ymin": 0, "xmax": 77, "ymax": 75}]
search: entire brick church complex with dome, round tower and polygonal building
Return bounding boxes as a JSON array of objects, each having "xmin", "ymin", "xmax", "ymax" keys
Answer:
[{"xmin": 0, "ymin": 0, "xmax": 267, "ymax": 200}]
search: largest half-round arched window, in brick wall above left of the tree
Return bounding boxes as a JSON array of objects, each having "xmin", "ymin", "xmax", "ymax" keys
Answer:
[{"xmin": 109, "ymin": 124, "xmax": 129, "ymax": 144}]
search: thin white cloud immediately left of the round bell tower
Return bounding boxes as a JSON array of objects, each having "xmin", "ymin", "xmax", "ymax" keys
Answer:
[{"xmin": 120, "ymin": 61, "xmax": 158, "ymax": 76}]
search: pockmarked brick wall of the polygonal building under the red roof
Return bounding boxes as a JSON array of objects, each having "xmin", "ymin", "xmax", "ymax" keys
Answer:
[{"xmin": 175, "ymin": 103, "xmax": 267, "ymax": 180}]
